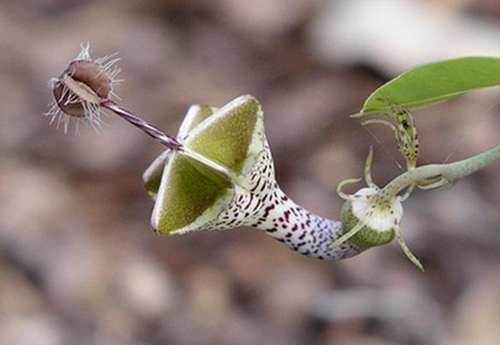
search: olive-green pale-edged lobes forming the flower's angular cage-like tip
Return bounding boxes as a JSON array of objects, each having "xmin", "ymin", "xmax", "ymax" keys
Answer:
[{"xmin": 143, "ymin": 96, "xmax": 265, "ymax": 234}]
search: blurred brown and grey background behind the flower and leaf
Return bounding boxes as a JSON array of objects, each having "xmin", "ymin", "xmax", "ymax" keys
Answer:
[{"xmin": 0, "ymin": 0, "xmax": 500, "ymax": 345}]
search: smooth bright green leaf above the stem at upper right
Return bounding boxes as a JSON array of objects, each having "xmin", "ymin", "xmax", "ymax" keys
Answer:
[{"xmin": 359, "ymin": 56, "xmax": 500, "ymax": 115}]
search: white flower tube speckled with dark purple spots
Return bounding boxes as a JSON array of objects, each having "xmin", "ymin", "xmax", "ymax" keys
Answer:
[{"xmin": 207, "ymin": 142, "xmax": 361, "ymax": 260}]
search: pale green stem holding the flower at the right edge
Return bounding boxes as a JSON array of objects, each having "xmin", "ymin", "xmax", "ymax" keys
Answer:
[{"xmin": 381, "ymin": 145, "xmax": 500, "ymax": 198}]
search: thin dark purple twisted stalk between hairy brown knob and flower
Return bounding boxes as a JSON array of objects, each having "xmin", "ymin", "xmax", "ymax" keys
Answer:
[{"xmin": 101, "ymin": 99, "xmax": 182, "ymax": 151}]
